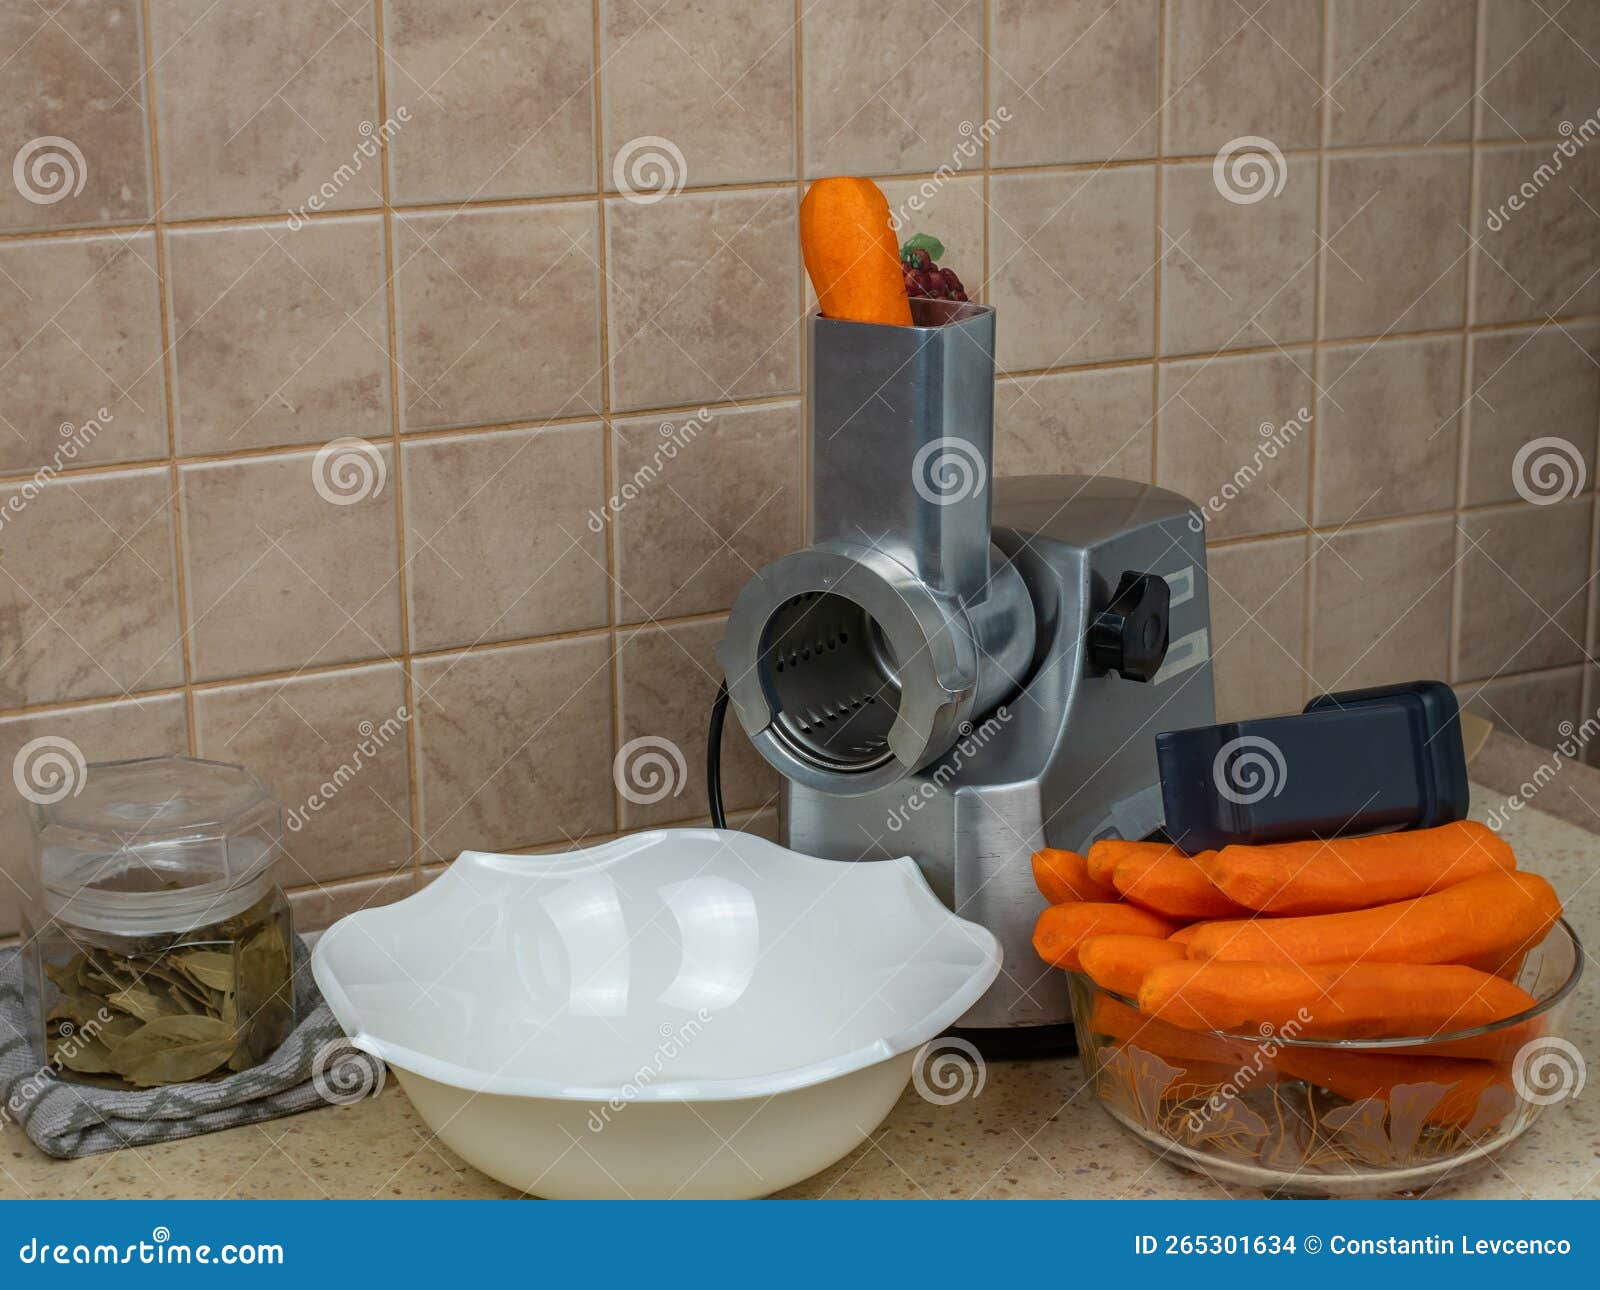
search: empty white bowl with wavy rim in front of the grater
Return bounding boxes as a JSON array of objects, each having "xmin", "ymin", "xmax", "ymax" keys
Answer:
[{"xmin": 312, "ymin": 829, "xmax": 1000, "ymax": 1197}]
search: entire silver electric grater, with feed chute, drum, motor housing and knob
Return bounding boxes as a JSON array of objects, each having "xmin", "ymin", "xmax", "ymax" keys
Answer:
[{"xmin": 717, "ymin": 299, "xmax": 1213, "ymax": 1047}]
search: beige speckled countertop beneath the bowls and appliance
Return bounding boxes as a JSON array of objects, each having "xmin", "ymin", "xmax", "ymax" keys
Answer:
[{"xmin": 0, "ymin": 736, "xmax": 1600, "ymax": 1199}]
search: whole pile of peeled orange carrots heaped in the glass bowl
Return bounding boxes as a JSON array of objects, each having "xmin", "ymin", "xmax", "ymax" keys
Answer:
[{"xmin": 1034, "ymin": 821, "xmax": 1562, "ymax": 1122}]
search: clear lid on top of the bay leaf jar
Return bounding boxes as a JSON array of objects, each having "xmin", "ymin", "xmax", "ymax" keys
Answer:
[{"xmin": 34, "ymin": 757, "xmax": 282, "ymax": 935}]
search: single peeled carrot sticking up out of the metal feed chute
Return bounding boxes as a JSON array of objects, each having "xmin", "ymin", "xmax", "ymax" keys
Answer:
[{"xmin": 800, "ymin": 176, "xmax": 910, "ymax": 327}]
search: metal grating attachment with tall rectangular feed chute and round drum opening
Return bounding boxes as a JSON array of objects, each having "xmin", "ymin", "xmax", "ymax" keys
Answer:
[{"xmin": 718, "ymin": 299, "xmax": 1035, "ymax": 795}]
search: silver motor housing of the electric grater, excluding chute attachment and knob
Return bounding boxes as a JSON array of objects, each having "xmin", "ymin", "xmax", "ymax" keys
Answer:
[{"xmin": 781, "ymin": 475, "xmax": 1213, "ymax": 1031}]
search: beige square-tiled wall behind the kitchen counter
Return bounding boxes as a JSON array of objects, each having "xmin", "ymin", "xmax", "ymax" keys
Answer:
[{"xmin": 0, "ymin": 0, "xmax": 1600, "ymax": 933}]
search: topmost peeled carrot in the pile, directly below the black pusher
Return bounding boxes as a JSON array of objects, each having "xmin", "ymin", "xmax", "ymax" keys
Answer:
[{"xmin": 1203, "ymin": 819, "xmax": 1517, "ymax": 914}]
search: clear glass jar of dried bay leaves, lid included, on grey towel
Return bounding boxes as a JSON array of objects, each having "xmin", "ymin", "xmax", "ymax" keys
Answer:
[{"xmin": 22, "ymin": 757, "xmax": 294, "ymax": 1088}]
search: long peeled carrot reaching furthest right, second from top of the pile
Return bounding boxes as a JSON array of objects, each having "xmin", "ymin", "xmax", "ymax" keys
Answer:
[{"xmin": 1189, "ymin": 872, "xmax": 1562, "ymax": 972}]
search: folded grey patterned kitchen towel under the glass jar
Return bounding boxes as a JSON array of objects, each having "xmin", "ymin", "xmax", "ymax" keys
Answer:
[{"xmin": 0, "ymin": 936, "xmax": 384, "ymax": 1159}]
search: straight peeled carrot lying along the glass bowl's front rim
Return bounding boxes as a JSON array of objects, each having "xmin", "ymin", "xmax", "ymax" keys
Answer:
[{"xmin": 1139, "ymin": 959, "xmax": 1534, "ymax": 1039}]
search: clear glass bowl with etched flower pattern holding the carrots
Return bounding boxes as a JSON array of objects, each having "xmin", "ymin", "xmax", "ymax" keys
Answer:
[{"xmin": 1072, "ymin": 919, "xmax": 1582, "ymax": 1196}]
